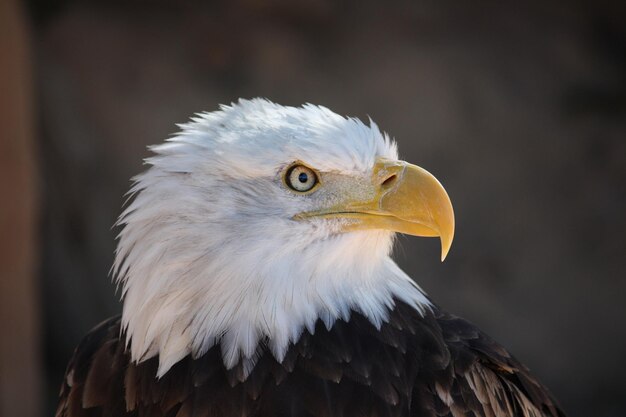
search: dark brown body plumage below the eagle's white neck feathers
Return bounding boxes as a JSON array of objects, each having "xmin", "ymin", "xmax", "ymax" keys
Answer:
[{"xmin": 56, "ymin": 302, "xmax": 564, "ymax": 417}]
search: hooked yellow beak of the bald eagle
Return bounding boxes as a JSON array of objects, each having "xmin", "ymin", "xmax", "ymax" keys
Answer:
[{"xmin": 296, "ymin": 158, "xmax": 454, "ymax": 261}]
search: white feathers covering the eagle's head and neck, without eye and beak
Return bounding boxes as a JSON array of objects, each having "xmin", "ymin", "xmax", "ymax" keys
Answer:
[{"xmin": 114, "ymin": 99, "xmax": 429, "ymax": 376}]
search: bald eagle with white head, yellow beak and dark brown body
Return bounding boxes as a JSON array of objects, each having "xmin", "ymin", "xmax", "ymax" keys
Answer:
[{"xmin": 56, "ymin": 99, "xmax": 564, "ymax": 417}]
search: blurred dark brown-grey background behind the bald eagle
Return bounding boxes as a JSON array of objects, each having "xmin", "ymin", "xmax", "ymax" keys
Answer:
[{"xmin": 0, "ymin": 0, "xmax": 626, "ymax": 417}]
